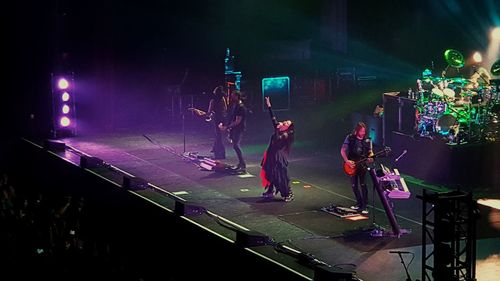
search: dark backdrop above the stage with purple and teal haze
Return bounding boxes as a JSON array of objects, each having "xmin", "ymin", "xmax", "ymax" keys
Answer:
[{"xmin": 2, "ymin": 0, "xmax": 500, "ymax": 137}]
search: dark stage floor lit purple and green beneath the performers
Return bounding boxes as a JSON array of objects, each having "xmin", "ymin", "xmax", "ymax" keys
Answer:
[{"xmin": 59, "ymin": 126, "xmax": 500, "ymax": 281}]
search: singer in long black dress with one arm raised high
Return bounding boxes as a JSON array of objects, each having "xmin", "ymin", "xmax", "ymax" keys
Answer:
[{"xmin": 260, "ymin": 97, "xmax": 295, "ymax": 202}]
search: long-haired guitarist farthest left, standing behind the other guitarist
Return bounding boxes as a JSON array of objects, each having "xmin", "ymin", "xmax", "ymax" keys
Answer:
[{"xmin": 207, "ymin": 86, "xmax": 228, "ymax": 159}]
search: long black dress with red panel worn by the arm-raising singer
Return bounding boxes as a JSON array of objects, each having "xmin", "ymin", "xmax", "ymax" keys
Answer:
[{"xmin": 260, "ymin": 107, "xmax": 294, "ymax": 197}]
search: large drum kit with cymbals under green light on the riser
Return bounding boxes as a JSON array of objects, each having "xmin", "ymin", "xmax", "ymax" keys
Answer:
[{"xmin": 411, "ymin": 49, "xmax": 500, "ymax": 144}]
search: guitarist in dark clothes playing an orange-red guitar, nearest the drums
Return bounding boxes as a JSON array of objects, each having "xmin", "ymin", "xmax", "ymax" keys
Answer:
[{"xmin": 340, "ymin": 122, "xmax": 373, "ymax": 214}]
